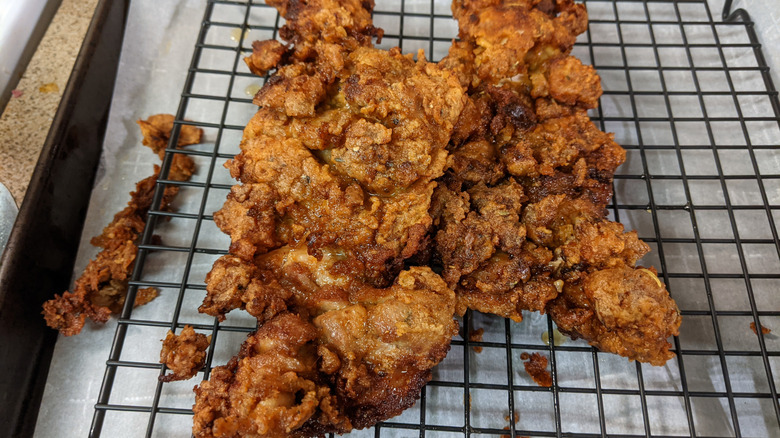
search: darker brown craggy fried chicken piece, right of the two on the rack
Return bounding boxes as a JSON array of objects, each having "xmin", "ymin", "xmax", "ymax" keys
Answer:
[{"xmin": 431, "ymin": 0, "xmax": 680, "ymax": 365}]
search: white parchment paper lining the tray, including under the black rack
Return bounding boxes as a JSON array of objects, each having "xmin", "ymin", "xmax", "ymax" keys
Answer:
[{"xmin": 36, "ymin": 0, "xmax": 780, "ymax": 437}]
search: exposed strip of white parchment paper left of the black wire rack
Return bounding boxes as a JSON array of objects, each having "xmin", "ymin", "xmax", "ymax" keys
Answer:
[{"xmin": 35, "ymin": 0, "xmax": 205, "ymax": 437}]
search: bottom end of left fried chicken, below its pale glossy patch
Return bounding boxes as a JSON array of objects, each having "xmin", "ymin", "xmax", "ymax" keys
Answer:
[{"xmin": 193, "ymin": 267, "xmax": 457, "ymax": 437}]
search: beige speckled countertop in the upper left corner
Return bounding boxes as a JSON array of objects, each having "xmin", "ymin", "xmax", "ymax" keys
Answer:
[{"xmin": 0, "ymin": 0, "xmax": 98, "ymax": 204}]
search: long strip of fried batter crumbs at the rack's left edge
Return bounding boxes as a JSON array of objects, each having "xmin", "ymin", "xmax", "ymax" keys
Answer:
[{"xmin": 43, "ymin": 114, "xmax": 203, "ymax": 336}]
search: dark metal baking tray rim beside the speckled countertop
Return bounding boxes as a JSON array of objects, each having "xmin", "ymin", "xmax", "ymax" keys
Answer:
[{"xmin": 0, "ymin": 0, "xmax": 129, "ymax": 437}]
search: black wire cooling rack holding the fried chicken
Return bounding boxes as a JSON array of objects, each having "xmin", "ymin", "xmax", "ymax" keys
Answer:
[{"xmin": 91, "ymin": 0, "xmax": 780, "ymax": 437}]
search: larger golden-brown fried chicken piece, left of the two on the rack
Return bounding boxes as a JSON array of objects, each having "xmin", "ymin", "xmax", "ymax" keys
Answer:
[{"xmin": 193, "ymin": 0, "xmax": 466, "ymax": 437}]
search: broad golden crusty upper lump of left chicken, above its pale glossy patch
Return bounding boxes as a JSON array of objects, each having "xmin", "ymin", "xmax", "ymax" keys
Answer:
[{"xmin": 219, "ymin": 47, "xmax": 465, "ymax": 286}]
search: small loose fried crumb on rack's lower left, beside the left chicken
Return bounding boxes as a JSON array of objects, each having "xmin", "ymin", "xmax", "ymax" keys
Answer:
[{"xmin": 159, "ymin": 325, "xmax": 211, "ymax": 382}]
